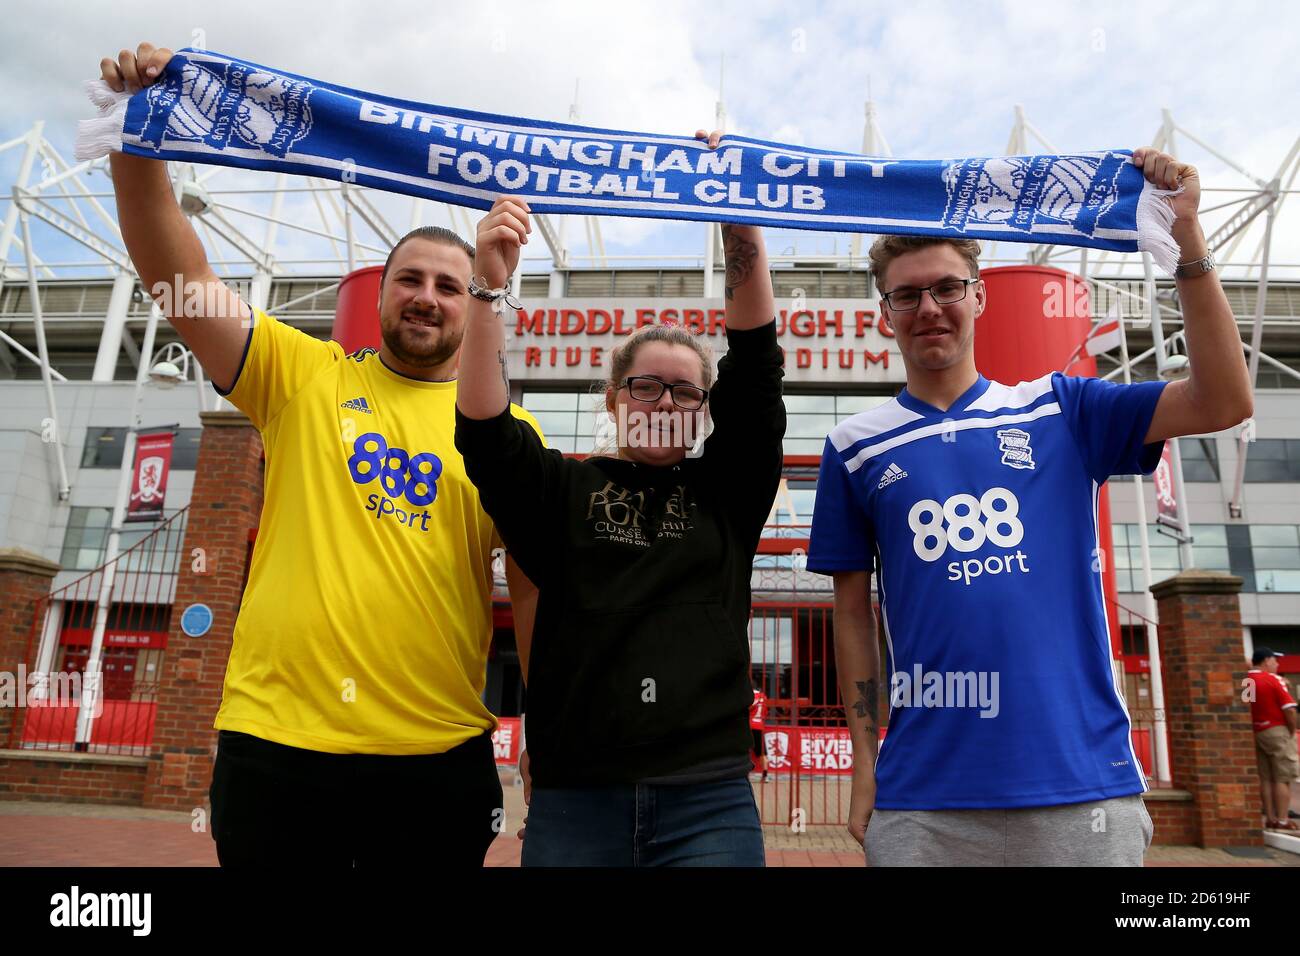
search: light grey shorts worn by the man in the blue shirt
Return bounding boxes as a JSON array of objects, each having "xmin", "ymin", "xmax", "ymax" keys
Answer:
[{"xmin": 866, "ymin": 796, "xmax": 1152, "ymax": 866}]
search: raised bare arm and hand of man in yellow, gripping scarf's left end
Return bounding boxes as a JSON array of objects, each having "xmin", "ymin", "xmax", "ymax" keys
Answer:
[{"xmin": 100, "ymin": 43, "xmax": 251, "ymax": 390}]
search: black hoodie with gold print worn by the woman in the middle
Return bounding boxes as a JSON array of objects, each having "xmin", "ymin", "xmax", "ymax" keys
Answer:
[{"xmin": 456, "ymin": 323, "xmax": 785, "ymax": 787}]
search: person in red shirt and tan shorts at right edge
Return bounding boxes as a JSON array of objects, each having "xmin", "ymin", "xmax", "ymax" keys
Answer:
[{"xmin": 1247, "ymin": 648, "xmax": 1300, "ymax": 830}]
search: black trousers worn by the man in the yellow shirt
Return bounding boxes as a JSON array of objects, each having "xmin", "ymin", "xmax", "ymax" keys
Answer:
[{"xmin": 208, "ymin": 731, "xmax": 501, "ymax": 869}]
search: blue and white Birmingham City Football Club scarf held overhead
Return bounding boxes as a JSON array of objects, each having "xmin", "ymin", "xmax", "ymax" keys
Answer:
[{"xmin": 77, "ymin": 49, "xmax": 1178, "ymax": 273}]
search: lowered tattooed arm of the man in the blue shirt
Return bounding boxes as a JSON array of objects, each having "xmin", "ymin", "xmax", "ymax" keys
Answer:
[{"xmin": 835, "ymin": 571, "xmax": 881, "ymax": 843}]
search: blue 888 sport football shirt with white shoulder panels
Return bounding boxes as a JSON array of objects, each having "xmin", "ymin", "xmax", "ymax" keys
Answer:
[{"xmin": 807, "ymin": 372, "xmax": 1165, "ymax": 810}]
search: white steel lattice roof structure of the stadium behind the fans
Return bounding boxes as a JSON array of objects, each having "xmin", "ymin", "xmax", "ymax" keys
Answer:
[{"xmin": 0, "ymin": 101, "xmax": 1300, "ymax": 388}]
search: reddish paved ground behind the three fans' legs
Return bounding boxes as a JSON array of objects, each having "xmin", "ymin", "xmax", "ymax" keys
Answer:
[{"xmin": 0, "ymin": 782, "xmax": 1300, "ymax": 866}]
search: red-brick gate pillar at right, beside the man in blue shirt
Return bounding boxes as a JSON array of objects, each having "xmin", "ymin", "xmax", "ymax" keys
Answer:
[{"xmin": 1151, "ymin": 568, "xmax": 1264, "ymax": 847}]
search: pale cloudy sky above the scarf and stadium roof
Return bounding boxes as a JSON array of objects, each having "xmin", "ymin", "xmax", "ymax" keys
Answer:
[{"xmin": 0, "ymin": 0, "xmax": 1300, "ymax": 276}]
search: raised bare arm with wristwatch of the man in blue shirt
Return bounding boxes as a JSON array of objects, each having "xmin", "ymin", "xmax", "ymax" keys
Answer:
[{"xmin": 1132, "ymin": 150, "xmax": 1255, "ymax": 444}]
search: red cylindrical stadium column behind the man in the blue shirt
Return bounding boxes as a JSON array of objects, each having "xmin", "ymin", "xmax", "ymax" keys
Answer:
[{"xmin": 975, "ymin": 265, "xmax": 1122, "ymax": 657}]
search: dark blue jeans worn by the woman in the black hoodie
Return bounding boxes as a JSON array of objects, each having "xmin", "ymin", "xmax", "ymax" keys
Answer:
[{"xmin": 521, "ymin": 777, "xmax": 766, "ymax": 866}]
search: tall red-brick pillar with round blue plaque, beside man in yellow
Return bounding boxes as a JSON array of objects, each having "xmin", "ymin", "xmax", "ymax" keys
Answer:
[{"xmin": 143, "ymin": 411, "xmax": 263, "ymax": 810}]
